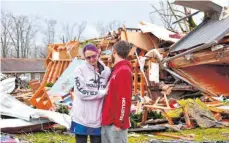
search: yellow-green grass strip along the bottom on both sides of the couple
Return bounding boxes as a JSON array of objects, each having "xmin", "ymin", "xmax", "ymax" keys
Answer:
[{"xmin": 17, "ymin": 127, "xmax": 229, "ymax": 143}]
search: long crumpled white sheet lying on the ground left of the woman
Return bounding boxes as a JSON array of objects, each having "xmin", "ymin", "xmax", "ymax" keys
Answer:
[{"xmin": 0, "ymin": 94, "xmax": 71, "ymax": 129}]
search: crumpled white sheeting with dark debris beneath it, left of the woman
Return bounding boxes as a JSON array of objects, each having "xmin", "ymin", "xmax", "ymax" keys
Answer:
[{"xmin": 0, "ymin": 94, "xmax": 71, "ymax": 133}]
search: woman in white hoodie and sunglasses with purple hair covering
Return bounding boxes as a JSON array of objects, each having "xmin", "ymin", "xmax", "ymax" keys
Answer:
[{"xmin": 70, "ymin": 44, "xmax": 110, "ymax": 143}]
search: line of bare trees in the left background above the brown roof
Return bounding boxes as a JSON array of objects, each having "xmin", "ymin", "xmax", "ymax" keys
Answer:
[{"xmin": 1, "ymin": 11, "xmax": 123, "ymax": 58}]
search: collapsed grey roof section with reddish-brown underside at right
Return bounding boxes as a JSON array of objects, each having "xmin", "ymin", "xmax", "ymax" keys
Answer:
[{"xmin": 164, "ymin": 1, "xmax": 229, "ymax": 96}]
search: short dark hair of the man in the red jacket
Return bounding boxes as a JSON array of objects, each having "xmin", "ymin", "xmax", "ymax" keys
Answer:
[{"xmin": 113, "ymin": 40, "xmax": 131, "ymax": 59}]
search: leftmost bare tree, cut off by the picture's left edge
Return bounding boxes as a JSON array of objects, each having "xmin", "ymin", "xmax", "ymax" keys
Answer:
[{"xmin": 1, "ymin": 11, "xmax": 12, "ymax": 58}]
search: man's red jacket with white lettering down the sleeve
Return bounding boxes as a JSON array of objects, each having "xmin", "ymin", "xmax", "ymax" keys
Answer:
[{"xmin": 102, "ymin": 60, "xmax": 132, "ymax": 129}]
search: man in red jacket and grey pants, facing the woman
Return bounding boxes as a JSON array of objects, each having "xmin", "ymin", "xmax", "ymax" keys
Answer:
[{"xmin": 101, "ymin": 41, "xmax": 132, "ymax": 143}]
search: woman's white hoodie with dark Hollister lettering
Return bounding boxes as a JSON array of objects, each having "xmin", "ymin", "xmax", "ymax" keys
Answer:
[{"xmin": 72, "ymin": 61, "xmax": 110, "ymax": 128}]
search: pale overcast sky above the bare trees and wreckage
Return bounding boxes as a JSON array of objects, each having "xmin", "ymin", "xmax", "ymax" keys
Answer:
[{"xmin": 1, "ymin": 0, "xmax": 229, "ymax": 43}]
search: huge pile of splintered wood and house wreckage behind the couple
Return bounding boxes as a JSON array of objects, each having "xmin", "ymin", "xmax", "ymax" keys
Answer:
[{"xmin": 1, "ymin": 0, "xmax": 229, "ymax": 140}]
